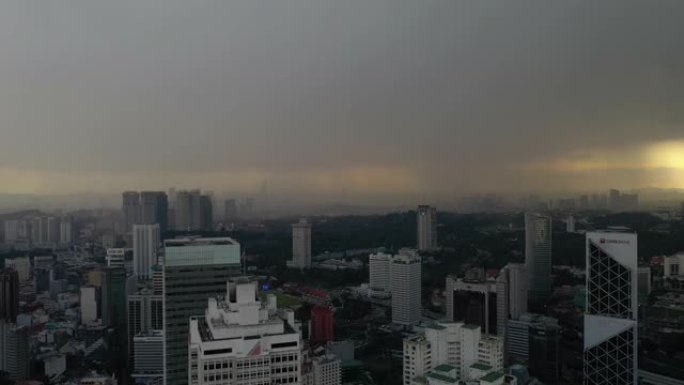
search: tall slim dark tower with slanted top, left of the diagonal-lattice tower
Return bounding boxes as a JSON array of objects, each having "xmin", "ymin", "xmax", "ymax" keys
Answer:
[{"xmin": 525, "ymin": 213, "xmax": 551, "ymax": 303}]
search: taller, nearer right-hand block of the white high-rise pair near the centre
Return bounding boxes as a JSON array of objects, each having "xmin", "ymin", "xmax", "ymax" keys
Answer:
[{"xmin": 390, "ymin": 254, "xmax": 423, "ymax": 325}]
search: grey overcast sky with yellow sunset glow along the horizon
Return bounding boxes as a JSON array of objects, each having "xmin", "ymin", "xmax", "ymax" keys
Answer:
[{"xmin": 0, "ymin": 0, "xmax": 684, "ymax": 201}]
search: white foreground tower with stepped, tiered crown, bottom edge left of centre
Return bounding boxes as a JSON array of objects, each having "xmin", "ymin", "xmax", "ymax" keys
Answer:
[{"xmin": 190, "ymin": 277, "xmax": 301, "ymax": 385}]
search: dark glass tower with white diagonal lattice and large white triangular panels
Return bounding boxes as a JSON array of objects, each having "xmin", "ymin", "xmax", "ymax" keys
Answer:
[{"xmin": 584, "ymin": 232, "xmax": 638, "ymax": 385}]
